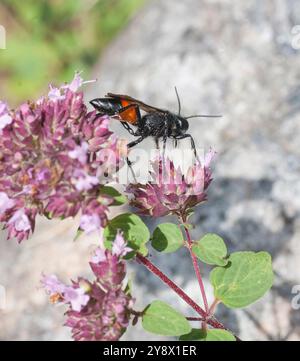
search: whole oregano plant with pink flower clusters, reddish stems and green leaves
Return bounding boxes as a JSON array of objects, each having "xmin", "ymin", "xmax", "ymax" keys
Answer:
[{"xmin": 0, "ymin": 73, "xmax": 273, "ymax": 341}]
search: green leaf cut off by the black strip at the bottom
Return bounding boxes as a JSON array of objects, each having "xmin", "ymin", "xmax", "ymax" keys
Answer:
[{"xmin": 179, "ymin": 328, "xmax": 235, "ymax": 341}]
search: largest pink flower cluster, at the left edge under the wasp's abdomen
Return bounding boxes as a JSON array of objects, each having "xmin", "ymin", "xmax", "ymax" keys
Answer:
[{"xmin": 0, "ymin": 73, "xmax": 126, "ymax": 241}]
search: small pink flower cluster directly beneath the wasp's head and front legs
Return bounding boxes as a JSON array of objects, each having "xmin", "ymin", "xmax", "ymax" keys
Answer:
[{"xmin": 127, "ymin": 150, "xmax": 215, "ymax": 217}]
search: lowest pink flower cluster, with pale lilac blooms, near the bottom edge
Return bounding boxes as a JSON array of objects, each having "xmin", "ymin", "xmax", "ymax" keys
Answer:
[{"xmin": 41, "ymin": 234, "xmax": 134, "ymax": 341}]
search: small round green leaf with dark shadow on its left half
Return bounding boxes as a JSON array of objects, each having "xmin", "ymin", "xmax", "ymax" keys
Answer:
[{"xmin": 152, "ymin": 223, "xmax": 184, "ymax": 253}]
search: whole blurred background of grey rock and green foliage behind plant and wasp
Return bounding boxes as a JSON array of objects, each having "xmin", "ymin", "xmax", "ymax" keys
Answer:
[{"xmin": 0, "ymin": 0, "xmax": 300, "ymax": 340}]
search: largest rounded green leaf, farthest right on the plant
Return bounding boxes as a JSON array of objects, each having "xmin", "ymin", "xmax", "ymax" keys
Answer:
[{"xmin": 210, "ymin": 252, "xmax": 273, "ymax": 308}]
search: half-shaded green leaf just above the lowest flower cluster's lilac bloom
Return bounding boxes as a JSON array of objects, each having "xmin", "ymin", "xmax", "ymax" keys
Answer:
[{"xmin": 103, "ymin": 213, "xmax": 150, "ymax": 258}]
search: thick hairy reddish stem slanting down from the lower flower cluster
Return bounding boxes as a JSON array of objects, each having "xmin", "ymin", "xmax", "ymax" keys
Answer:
[{"xmin": 136, "ymin": 254, "xmax": 232, "ymax": 339}]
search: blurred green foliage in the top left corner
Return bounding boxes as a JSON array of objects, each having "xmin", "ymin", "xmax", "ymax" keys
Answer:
[{"xmin": 0, "ymin": 0, "xmax": 144, "ymax": 105}]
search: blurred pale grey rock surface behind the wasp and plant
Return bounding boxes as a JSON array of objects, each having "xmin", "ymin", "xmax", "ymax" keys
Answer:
[{"xmin": 0, "ymin": 0, "xmax": 300, "ymax": 340}]
